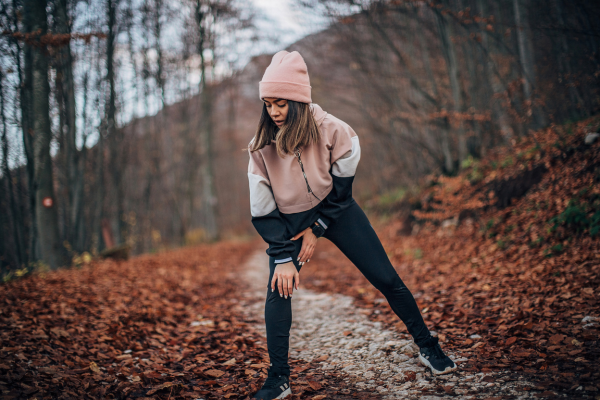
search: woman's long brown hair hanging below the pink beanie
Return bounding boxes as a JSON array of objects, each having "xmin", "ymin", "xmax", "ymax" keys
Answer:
[{"xmin": 250, "ymin": 100, "xmax": 320, "ymax": 158}]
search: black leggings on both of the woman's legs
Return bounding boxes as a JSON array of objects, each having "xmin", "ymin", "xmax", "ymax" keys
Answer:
[{"xmin": 265, "ymin": 200, "xmax": 430, "ymax": 375}]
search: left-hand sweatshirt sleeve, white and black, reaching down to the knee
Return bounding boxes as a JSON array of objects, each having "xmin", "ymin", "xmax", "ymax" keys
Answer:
[{"xmin": 248, "ymin": 143, "xmax": 295, "ymax": 264}]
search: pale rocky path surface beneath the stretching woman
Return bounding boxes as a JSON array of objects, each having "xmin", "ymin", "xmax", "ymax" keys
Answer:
[{"xmin": 238, "ymin": 249, "xmax": 540, "ymax": 400}]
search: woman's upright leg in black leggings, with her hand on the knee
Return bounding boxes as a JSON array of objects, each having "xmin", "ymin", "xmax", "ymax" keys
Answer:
[{"xmin": 265, "ymin": 238, "xmax": 302, "ymax": 376}]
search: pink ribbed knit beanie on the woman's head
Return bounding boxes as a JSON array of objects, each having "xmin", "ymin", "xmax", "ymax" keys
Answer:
[{"xmin": 258, "ymin": 50, "xmax": 312, "ymax": 103}]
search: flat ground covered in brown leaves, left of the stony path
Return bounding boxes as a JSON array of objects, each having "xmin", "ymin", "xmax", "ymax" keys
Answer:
[{"xmin": 0, "ymin": 241, "xmax": 368, "ymax": 399}]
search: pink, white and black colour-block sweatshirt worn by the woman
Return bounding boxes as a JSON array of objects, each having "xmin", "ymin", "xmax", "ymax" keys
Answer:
[{"xmin": 248, "ymin": 104, "xmax": 360, "ymax": 263}]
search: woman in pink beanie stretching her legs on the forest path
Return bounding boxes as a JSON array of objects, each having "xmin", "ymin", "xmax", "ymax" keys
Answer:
[{"xmin": 248, "ymin": 51, "xmax": 456, "ymax": 399}]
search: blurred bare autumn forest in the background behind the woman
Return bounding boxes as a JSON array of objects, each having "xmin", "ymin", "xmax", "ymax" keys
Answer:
[{"xmin": 0, "ymin": 0, "xmax": 600, "ymax": 274}]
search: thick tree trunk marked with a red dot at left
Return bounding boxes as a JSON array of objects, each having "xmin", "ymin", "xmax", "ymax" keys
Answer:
[{"xmin": 24, "ymin": 0, "xmax": 67, "ymax": 269}]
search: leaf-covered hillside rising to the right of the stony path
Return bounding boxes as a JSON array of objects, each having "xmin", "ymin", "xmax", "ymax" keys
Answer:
[{"xmin": 304, "ymin": 117, "xmax": 600, "ymax": 398}]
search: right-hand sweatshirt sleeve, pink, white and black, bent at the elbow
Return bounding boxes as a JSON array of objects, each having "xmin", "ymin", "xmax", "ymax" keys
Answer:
[{"xmin": 313, "ymin": 120, "xmax": 360, "ymax": 237}]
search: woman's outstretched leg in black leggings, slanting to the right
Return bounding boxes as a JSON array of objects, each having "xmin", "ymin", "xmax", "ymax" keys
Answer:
[{"xmin": 324, "ymin": 201, "xmax": 430, "ymax": 347}]
